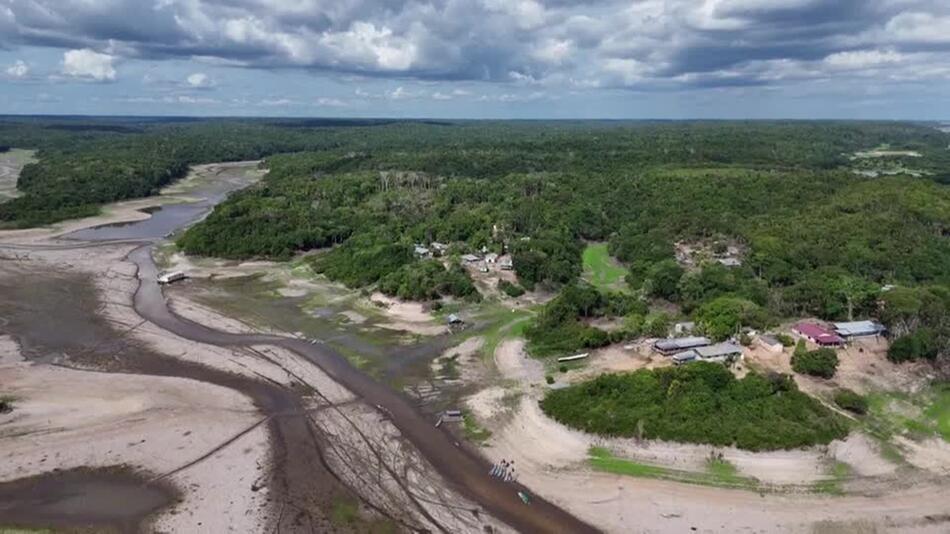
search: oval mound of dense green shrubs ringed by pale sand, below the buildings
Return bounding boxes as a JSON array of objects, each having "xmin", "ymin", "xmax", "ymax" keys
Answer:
[{"xmin": 541, "ymin": 362, "xmax": 848, "ymax": 451}]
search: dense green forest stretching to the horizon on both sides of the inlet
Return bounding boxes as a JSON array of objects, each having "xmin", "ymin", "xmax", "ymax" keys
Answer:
[{"xmin": 0, "ymin": 119, "xmax": 950, "ymax": 366}]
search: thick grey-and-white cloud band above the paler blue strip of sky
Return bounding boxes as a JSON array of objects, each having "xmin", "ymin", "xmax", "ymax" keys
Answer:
[{"xmin": 0, "ymin": 0, "xmax": 950, "ymax": 88}]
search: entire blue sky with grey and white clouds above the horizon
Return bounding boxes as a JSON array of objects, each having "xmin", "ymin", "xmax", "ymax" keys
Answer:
[{"xmin": 0, "ymin": 0, "xmax": 950, "ymax": 119}]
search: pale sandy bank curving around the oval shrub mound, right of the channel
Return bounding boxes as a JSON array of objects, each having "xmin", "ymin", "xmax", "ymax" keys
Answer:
[{"xmin": 468, "ymin": 340, "xmax": 947, "ymax": 532}]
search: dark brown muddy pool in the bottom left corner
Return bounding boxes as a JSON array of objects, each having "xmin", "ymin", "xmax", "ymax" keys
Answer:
[{"xmin": 0, "ymin": 467, "xmax": 179, "ymax": 533}]
